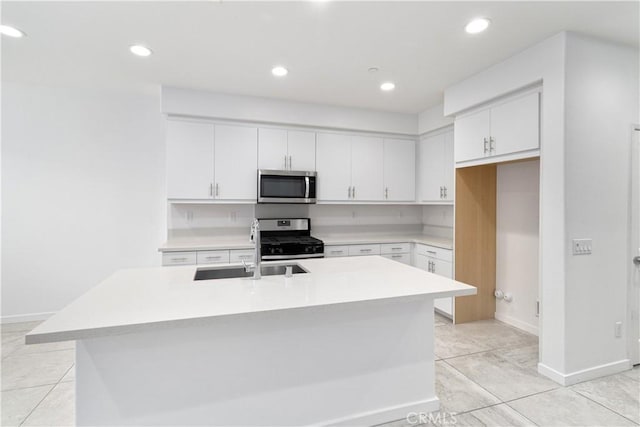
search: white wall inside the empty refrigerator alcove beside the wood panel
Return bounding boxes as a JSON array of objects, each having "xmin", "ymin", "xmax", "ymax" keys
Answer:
[{"xmin": 496, "ymin": 160, "xmax": 540, "ymax": 334}]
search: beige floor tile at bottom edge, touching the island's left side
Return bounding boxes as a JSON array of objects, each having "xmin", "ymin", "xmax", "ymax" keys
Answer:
[{"xmin": 23, "ymin": 382, "xmax": 75, "ymax": 427}]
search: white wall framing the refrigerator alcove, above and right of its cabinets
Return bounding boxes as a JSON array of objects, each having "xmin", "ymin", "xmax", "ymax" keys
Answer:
[{"xmin": 444, "ymin": 33, "xmax": 568, "ymax": 381}]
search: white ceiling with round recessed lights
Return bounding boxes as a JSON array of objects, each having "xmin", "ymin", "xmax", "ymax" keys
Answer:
[{"xmin": 2, "ymin": 0, "xmax": 639, "ymax": 113}]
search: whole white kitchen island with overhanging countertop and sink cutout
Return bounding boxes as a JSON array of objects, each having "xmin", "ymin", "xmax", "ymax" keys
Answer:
[{"xmin": 26, "ymin": 256, "xmax": 476, "ymax": 425}]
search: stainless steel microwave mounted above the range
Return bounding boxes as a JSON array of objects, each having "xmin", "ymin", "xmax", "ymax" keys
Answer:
[{"xmin": 258, "ymin": 169, "xmax": 317, "ymax": 203}]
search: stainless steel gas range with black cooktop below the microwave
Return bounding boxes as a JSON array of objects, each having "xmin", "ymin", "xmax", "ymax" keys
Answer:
[{"xmin": 258, "ymin": 218, "xmax": 324, "ymax": 261}]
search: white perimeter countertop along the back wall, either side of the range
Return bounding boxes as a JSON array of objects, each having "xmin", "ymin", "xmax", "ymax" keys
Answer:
[{"xmin": 158, "ymin": 233, "xmax": 453, "ymax": 252}]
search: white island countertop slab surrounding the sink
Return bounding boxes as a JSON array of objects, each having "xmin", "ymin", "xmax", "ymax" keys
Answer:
[{"xmin": 26, "ymin": 256, "xmax": 476, "ymax": 344}]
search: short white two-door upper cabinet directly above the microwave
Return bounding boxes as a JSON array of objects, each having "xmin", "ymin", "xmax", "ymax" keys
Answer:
[{"xmin": 258, "ymin": 128, "xmax": 316, "ymax": 171}]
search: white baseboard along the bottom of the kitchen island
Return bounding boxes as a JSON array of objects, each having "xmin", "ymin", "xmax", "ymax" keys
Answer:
[{"xmin": 316, "ymin": 397, "xmax": 440, "ymax": 426}]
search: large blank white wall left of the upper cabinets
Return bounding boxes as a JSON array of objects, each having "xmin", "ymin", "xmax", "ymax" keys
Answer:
[{"xmin": 2, "ymin": 82, "xmax": 166, "ymax": 321}]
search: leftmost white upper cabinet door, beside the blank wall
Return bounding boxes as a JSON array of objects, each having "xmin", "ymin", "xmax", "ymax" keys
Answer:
[{"xmin": 167, "ymin": 120, "xmax": 213, "ymax": 199}]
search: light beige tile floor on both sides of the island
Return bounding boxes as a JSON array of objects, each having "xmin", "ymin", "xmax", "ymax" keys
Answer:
[{"xmin": 1, "ymin": 315, "xmax": 640, "ymax": 427}]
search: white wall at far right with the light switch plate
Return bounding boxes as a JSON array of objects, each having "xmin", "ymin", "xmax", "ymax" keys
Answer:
[{"xmin": 565, "ymin": 34, "xmax": 639, "ymax": 373}]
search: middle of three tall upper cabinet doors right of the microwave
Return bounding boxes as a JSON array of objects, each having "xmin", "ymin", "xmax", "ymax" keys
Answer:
[{"xmin": 351, "ymin": 136, "xmax": 384, "ymax": 201}]
